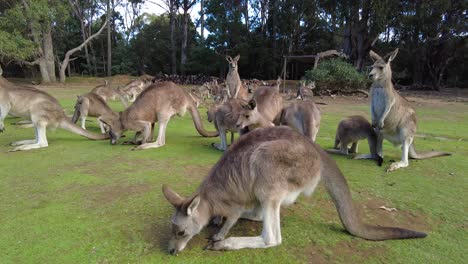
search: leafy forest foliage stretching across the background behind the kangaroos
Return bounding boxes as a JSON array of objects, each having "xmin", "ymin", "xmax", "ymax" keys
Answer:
[{"xmin": 0, "ymin": 0, "xmax": 468, "ymax": 87}]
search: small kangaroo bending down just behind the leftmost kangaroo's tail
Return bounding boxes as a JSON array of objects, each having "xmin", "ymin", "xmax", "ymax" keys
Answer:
[{"xmin": 72, "ymin": 93, "xmax": 117, "ymax": 134}]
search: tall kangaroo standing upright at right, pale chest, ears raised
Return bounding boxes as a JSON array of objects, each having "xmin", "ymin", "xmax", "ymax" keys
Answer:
[{"xmin": 369, "ymin": 49, "xmax": 451, "ymax": 172}]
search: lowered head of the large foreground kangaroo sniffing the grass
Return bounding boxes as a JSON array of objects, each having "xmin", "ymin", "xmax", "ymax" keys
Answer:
[{"xmin": 162, "ymin": 185, "xmax": 209, "ymax": 255}]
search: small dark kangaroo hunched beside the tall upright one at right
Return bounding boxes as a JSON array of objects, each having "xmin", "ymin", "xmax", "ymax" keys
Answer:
[{"xmin": 327, "ymin": 115, "xmax": 383, "ymax": 166}]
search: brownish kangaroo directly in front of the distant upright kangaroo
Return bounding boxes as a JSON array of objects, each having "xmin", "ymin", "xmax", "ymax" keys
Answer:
[{"xmin": 207, "ymin": 99, "xmax": 245, "ymax": 151}]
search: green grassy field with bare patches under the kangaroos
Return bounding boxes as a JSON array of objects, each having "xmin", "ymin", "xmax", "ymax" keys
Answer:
[{"xmin": 0, "ymin": 83, "xmax": 468, "ymax": 263}]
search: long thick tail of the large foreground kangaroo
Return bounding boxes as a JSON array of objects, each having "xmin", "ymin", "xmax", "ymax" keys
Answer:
[{"xmin": 319, "ymin": 150, "xmax": 427, "ymax": 240}]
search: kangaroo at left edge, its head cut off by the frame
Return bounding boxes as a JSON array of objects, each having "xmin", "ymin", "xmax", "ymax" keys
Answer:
[{"xmin": 0, "ymin": 76, "xmax": 108, "ymax": 151}]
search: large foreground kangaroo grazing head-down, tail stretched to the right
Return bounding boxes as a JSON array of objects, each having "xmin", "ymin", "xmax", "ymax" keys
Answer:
[{"xmin": 162, "ymin": 126, "xmax": 426, "ymax": 255}]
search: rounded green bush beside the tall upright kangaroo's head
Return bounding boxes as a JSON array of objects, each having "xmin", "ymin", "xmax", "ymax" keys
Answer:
[{"xmin": 305, "ymin": 58, "xmax": 368, "ymax": 90}]
